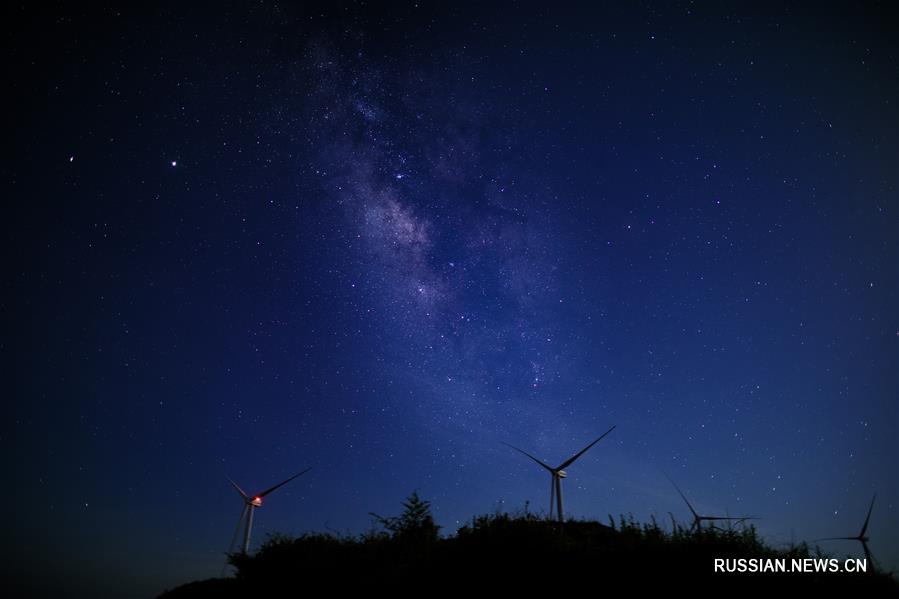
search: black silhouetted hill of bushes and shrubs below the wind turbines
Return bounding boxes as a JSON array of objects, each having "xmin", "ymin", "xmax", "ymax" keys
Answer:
[{"xmin": 163, "ymin": 493, "xmax": 899, "ymax": 599}]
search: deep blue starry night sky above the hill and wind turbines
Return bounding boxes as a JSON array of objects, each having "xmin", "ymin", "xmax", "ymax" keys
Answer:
[{"xmin": 7, "ymin": 2, "xmax": 899, "ymax": 597}]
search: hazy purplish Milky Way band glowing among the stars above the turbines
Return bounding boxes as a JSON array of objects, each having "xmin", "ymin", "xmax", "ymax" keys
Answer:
[{"xmin": 307, "ymin": 42, "xmax": 562, "ymax": 434}]
